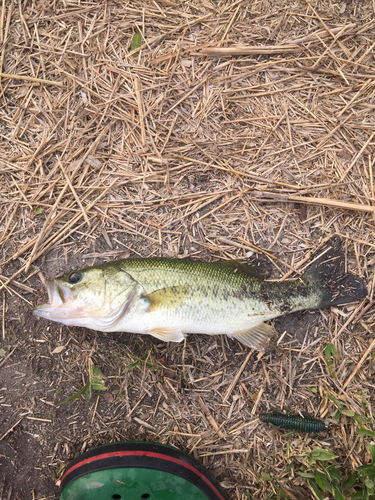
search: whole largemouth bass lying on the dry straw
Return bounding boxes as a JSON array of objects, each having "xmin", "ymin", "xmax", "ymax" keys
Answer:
[{"xmin": 34, "ymin": 237, "xmax": 367, "ymax": 349}]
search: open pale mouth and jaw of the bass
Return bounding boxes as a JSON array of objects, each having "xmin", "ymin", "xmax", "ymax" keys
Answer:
[{"xmin": 33, "ymin": 280, "xmax": 75, "ymax": 320}]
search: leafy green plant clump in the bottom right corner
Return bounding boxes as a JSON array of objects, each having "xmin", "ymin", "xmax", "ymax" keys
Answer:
[{"xmin": 297, "ymin": 445, "xmax": 375, "ymax": 500}]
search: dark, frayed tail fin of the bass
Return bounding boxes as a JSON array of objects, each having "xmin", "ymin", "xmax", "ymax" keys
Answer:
[{"xmin": 301, "ymin": 236, "xmax": 367, "ymax": 308}]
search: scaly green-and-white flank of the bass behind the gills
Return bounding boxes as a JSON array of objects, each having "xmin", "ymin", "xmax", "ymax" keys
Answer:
[{"xmin": 121, "ymin": 259, "xmax": 272, "ymax": 334}]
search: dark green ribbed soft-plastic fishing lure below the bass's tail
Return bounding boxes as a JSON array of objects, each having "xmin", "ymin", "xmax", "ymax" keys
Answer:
[{"xmin": 259, "ymin": 410, "xmax": 327, "ymax": 434}]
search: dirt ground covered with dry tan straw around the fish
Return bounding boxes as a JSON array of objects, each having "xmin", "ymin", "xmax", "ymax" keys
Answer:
[{"xmin": 0, "ymin": 0, "xmax": 375, "ymax": 500}]
